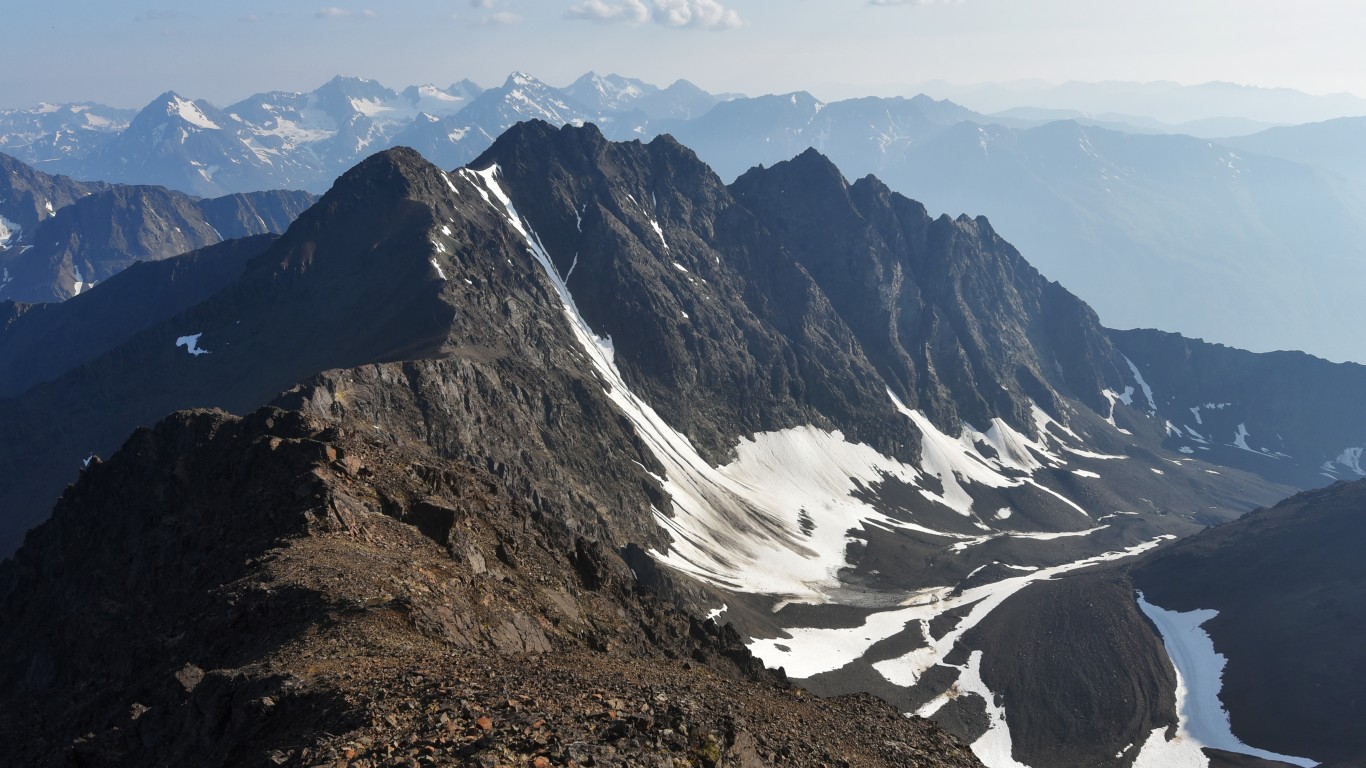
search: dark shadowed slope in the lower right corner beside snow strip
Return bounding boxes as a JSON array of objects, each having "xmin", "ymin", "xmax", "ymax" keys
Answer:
[{"xmin": 1132, "ymin": 481, "xmax": 1366, "ymax": 765}]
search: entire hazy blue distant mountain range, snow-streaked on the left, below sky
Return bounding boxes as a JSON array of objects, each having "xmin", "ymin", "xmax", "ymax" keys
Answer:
[{"xmin": 8, "ymin": 72, "xmax": 1366, "ymax": 361}]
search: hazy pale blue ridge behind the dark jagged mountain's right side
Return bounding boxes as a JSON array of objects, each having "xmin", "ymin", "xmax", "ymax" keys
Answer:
[{"xmin": 684, "ymin": 114, "xmax": 1366, "ymax": 361}]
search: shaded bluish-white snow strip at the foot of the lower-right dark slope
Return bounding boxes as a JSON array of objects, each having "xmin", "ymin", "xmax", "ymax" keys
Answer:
[{"xmin": 1135, "ymin": 592, "xmax": 1318, "ymax": 768}]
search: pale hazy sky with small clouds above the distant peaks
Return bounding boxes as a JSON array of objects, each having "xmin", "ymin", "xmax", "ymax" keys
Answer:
[{"xmin": 0, "ymin": 0, "xmax": 1366, "ymax": 107}]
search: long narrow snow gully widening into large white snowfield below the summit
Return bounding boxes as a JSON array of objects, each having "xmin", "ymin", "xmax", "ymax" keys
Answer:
[{"xmin": 470, "ymin": 165, "xmax": 961, "ymax": 601}]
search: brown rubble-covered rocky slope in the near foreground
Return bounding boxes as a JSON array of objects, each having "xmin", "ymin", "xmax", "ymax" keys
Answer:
[{"xmin": 0, "ymin": 410, "xmax": 978, "ymax": 768}]
